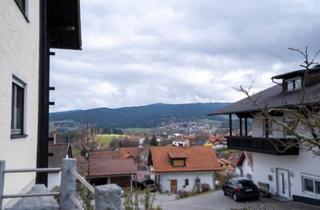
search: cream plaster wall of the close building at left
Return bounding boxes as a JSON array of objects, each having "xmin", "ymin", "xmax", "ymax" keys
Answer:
[{"xmin": 0, "ymin": 0, "xmax": 39, "ymax": 203}]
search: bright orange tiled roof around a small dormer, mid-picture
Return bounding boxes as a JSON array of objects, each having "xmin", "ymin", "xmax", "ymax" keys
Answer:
[{"xmin": 150, "ymin": 146, "xmax": 222, "ymax": 173}]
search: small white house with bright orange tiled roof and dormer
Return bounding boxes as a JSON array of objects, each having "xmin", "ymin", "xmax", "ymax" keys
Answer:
[{"xmin": 149, "ymin": 146, "xmax": 222, "ymax": 193}]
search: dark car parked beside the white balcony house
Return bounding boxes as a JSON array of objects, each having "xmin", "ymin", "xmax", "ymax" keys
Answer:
[{"xmin": 222, "ymin": 177, "xmax": 259, "ymax": 201}]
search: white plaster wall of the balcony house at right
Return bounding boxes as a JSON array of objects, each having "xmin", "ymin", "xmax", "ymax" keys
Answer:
[{"xmin": 252, "ymin": 114, "xmax": 320, "ymax": 199}]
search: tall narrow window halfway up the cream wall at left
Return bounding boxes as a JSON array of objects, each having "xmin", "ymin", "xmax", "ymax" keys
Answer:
[{"xmin": 11, "ymin": 77, "xmax": 25, "ymax": 136}]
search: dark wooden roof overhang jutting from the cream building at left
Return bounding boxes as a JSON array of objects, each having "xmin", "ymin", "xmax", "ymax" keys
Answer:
[{"xmin": 47, "ymin": 0, "xmax": 82, "ymax": 50}]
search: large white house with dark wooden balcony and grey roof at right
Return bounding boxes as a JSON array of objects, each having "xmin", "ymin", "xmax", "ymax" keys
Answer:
[{"xmin": 212, "ymin": 65, "xmax": 320, "ymax": 204}]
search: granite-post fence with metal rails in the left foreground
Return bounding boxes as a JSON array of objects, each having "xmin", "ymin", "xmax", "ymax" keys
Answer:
[{"xmin": 0, "ymin": 159, "xmax": 122, "ymax": 210}]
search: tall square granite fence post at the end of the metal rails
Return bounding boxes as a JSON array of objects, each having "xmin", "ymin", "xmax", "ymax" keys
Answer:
[{"xmin": 60, "ymin": 159, "xmax": 77, "ymax": 210}]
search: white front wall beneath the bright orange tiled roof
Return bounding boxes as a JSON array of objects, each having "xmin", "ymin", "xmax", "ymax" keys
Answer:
[{"xmin": 159, "ymin": 172, "xmax": 215, "ymax": 193}]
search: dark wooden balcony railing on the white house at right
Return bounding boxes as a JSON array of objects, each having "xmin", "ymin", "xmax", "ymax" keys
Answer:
[{"xmin": 227, "ymin": 136, "xmax": 299, "ymax": 155}]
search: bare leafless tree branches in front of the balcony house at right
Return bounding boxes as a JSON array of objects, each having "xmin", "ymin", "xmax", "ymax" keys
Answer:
[{"xmin": 238, "ymin": 47, "xmax": 320, "ymax": 156}]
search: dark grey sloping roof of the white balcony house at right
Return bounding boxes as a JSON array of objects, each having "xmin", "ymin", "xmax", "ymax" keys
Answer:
[{"xmin": 209, "ymin": 84, "xmax": 320, "ymax": 115}]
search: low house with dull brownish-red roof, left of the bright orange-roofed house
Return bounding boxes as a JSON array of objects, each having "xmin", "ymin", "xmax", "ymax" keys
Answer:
[{"xmin": 77, "ymin": 147, "xmax": 150, "ymax": 187}]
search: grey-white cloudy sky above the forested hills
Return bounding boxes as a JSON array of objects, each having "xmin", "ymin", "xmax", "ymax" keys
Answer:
[{"xmin": 51, "ymin": 0, "xmax": 320, "ymax": 111}]
